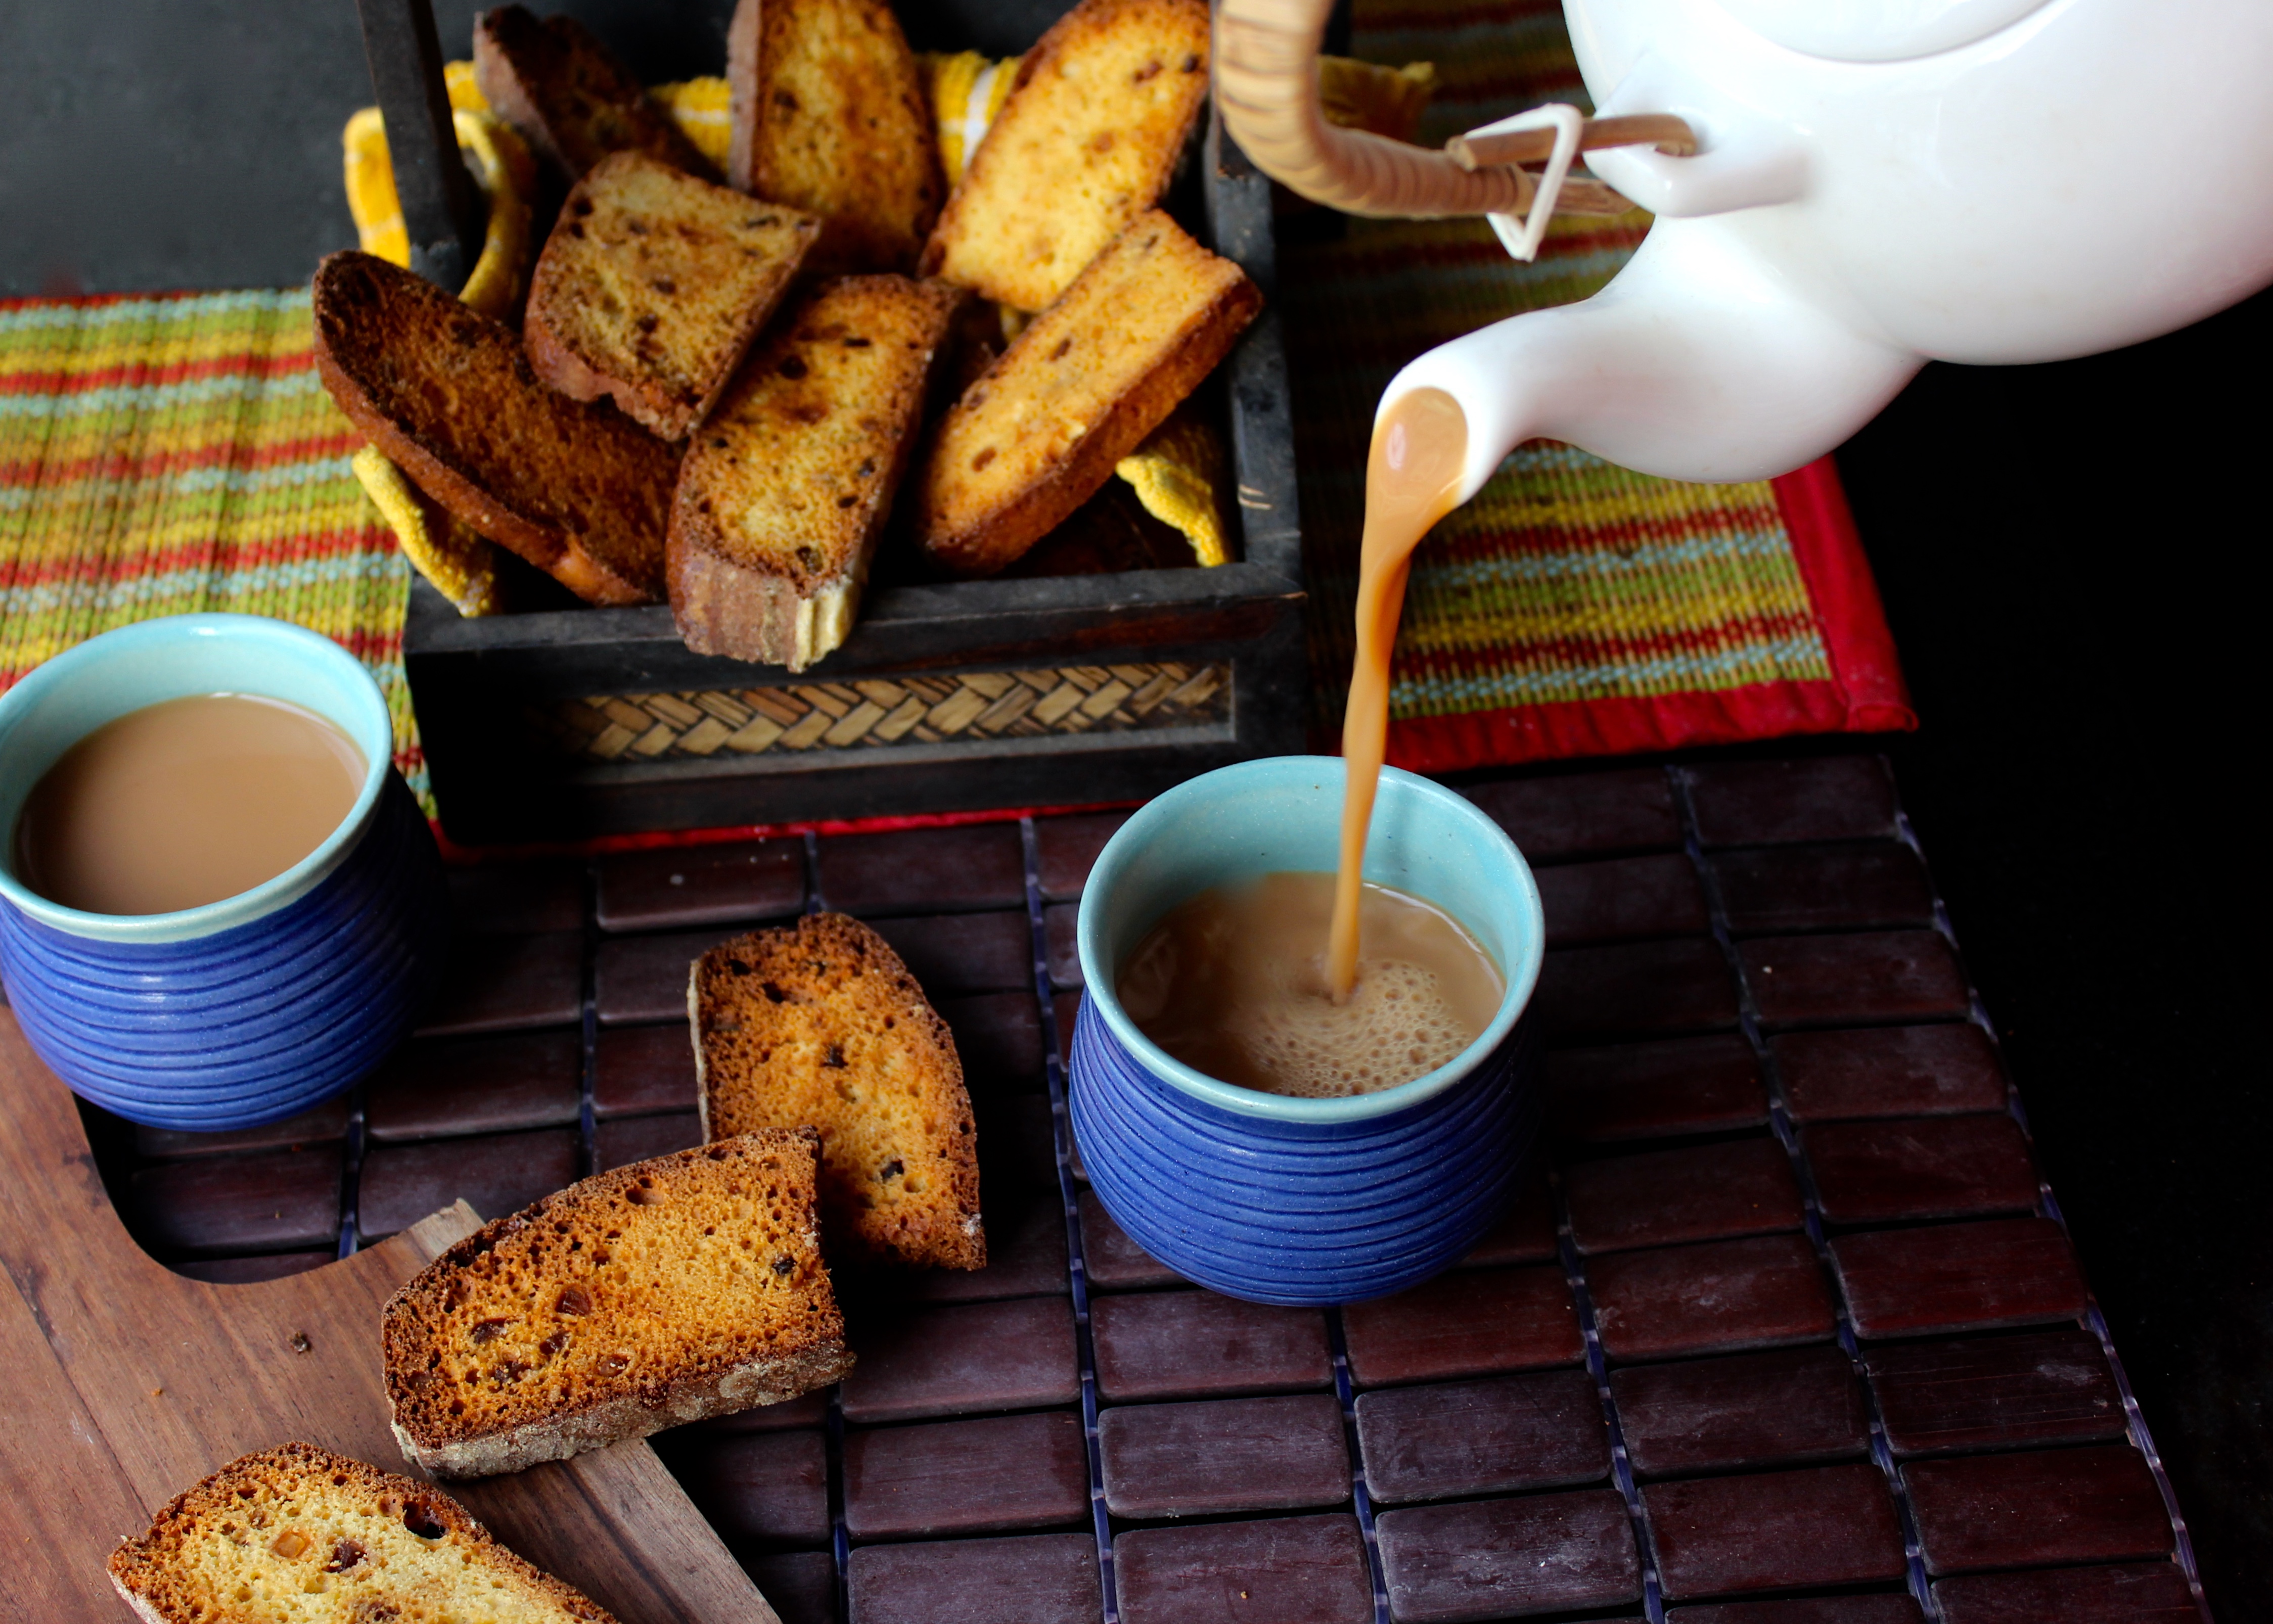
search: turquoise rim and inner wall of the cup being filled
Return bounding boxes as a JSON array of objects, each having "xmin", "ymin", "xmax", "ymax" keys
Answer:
[{"xmin": 1075, "ymin": 756, "xmax": 1545, "ymax": 1127}]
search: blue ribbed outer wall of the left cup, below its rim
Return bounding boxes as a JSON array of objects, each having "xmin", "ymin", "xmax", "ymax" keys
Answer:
[{"xmin": 0, "ymin": 772, "xmax": 448, "ymax": 1131}]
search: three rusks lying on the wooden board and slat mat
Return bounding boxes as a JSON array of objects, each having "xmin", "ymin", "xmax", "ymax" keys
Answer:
[{"xmin": 109, "ymin": 913, "xmax": 986, "ymax": 1624}]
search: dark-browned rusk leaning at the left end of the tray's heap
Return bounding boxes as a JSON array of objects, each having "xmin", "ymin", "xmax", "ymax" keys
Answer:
[{"xmin": 316, "ymin": 250, "xmax": 679, "ymax": 604}]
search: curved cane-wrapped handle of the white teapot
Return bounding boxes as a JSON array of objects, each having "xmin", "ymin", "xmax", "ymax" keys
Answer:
[{"xmin": 1216, "ymin": 0, "xmax": 1532, "ymax": 220}]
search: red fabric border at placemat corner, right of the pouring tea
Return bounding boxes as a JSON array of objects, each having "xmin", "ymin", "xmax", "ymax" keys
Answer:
[{"xmin": 1389, "ymin": 456, "xmax": 1919, "ymax": 772}]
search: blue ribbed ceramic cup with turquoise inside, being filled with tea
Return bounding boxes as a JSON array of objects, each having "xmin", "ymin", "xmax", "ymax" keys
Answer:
[{"xmin": 1071, "ymin": 756, "xmax": 1545, "ymax": 1306}]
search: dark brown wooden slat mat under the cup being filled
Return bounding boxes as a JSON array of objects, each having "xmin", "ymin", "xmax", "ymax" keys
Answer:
[{"xmin": 71, "ymin": 756, "xmax": 2200, "ymax": 1624}]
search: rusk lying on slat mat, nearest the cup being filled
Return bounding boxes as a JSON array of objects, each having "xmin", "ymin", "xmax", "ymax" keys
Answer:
[{"xmin": 687, "ymin": 913, "xmax": 986, "ymax": 1270}]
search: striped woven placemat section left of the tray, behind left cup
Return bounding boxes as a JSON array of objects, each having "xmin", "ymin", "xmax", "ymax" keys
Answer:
[{"xmin": 0, "ymin": 289, "xmax": 425, "ymax": 797}]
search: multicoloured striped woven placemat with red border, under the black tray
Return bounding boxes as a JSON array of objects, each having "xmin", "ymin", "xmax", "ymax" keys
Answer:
[{"xmin": 0, "ymin": 0, "xmax": 1912, "ymax": 817}]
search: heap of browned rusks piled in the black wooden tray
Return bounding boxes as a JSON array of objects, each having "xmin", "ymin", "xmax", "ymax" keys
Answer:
[{"xmin": 316, "ymin": 0, "xmax": 1261, "ymax": 670}]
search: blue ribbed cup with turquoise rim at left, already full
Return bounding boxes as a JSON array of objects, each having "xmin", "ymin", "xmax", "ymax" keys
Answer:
[{"xmin": 0, "ymin": 616, "xmax": 448, "ymax": 1131}]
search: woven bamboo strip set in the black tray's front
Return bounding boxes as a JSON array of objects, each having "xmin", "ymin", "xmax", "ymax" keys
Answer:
[{"xmin": 527, "ymin": 661, "xmax": 1232, "ymax": 761}]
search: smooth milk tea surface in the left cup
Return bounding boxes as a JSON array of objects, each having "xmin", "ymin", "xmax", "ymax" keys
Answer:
[{"xmin": 14, "ymin": 693, "xmax": 366, "ymax": 913}]
